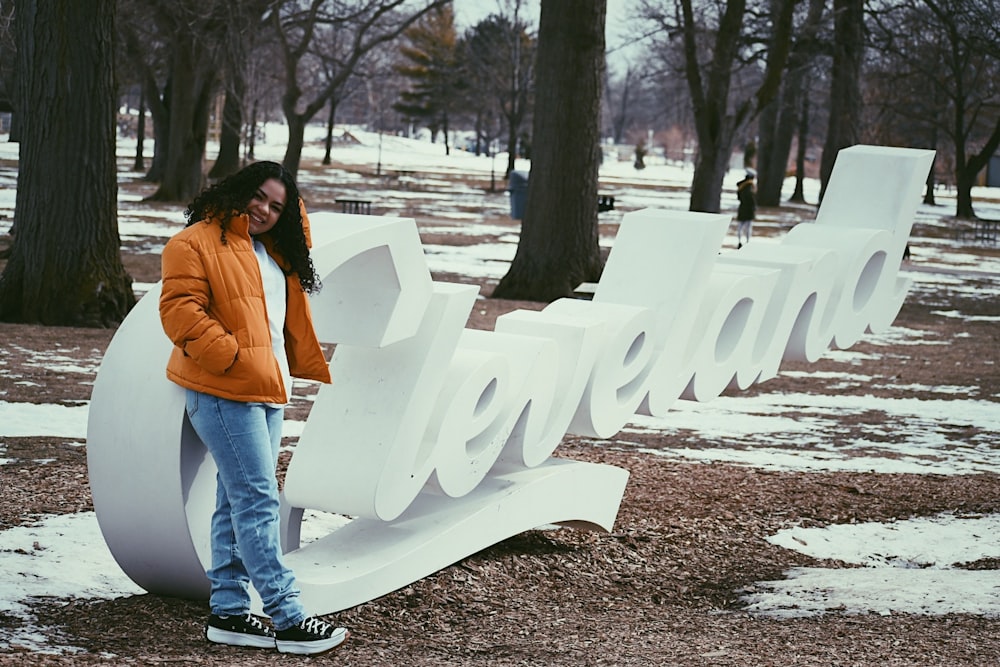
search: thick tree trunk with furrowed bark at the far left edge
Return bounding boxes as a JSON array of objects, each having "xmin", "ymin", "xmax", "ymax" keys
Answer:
[{"xmin": 0, "ymin": 0, "xmax": 135, "ymax": 327}]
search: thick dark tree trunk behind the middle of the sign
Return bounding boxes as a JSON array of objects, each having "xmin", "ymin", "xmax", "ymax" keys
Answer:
[{"xmin": 493, "ymin": 0, "xmax": 607, "ymax": 301}]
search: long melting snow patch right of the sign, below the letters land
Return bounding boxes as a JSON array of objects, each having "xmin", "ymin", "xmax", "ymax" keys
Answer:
[{"xmin": 615, "ymin": 394, "xmax": 1000, "ymax": 475}]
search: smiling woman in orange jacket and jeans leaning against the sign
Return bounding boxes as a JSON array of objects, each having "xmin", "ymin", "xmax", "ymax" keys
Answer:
[{"xmin": 160, "ymin": 162, "xmax": 349, "ymax": 655}]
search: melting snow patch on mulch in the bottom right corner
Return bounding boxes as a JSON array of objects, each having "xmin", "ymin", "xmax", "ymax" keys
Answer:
[{"xmin": 743, "ymin": 515, "xmax": 1000, "ymax": 618}]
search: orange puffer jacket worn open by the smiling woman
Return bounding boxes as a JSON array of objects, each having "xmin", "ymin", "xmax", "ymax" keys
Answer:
[{"xmin": 160, "ymin": 210, "xmax": 330, "ymax": 403}]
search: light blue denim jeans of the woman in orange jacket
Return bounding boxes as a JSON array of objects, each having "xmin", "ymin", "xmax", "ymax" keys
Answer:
[{"xmin": 187, "ymin": 389, "xmax": 306, "ymax": 630}]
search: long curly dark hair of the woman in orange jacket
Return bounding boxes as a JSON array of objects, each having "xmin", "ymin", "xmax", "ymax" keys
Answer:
[{"xmin": 184, "ymin": 161, "xmax": 321, "ymax": 293}]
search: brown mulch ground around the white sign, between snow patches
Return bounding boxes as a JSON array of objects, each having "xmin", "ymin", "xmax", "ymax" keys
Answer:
[{"xmin": 0, "ymin": 159, "xmax": 1000, "ymax": 666}]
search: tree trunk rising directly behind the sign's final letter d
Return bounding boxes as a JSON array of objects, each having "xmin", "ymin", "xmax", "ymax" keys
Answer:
[{"xmin": 819, "ymin": 0, "xmax": 865, "ymax": 200}]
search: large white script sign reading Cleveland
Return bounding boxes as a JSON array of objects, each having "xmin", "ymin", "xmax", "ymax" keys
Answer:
[{"xmin": 87, "ymin": 146, "xmax": 933, "ymax": 613}]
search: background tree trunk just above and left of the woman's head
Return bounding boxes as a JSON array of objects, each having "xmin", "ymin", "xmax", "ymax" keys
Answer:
[{"xmin": 150, "ymin": 35, "xmax": 216, "ymax": 202}]
